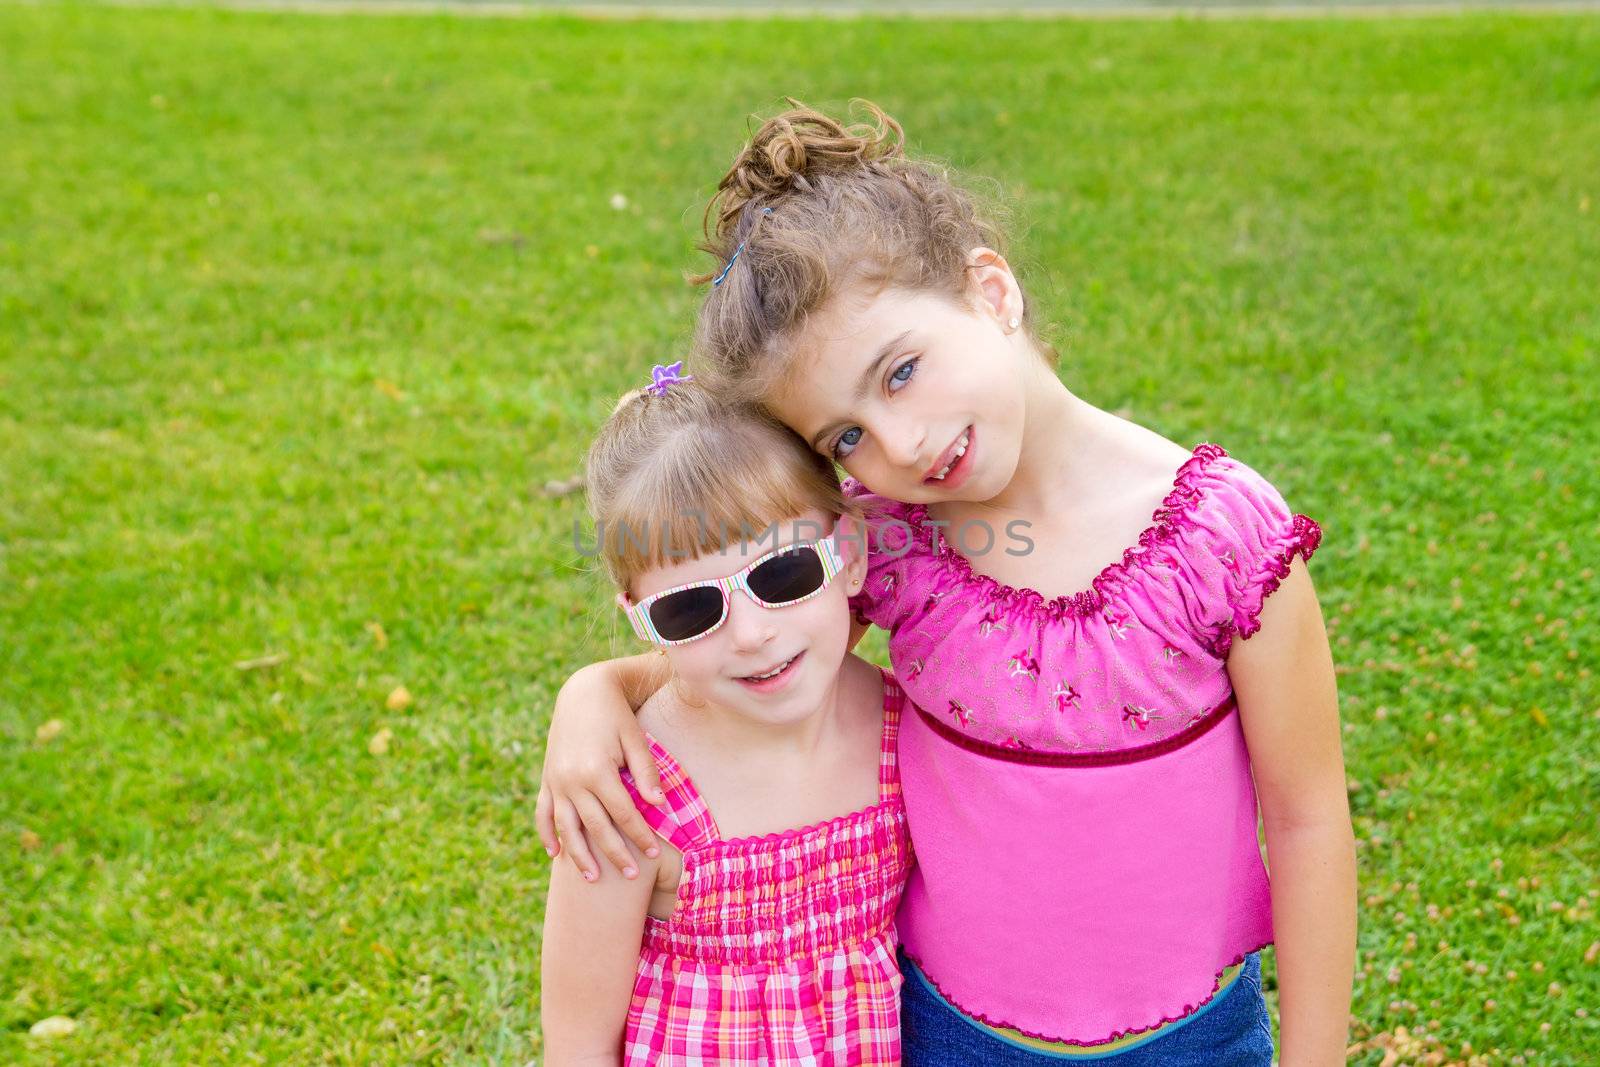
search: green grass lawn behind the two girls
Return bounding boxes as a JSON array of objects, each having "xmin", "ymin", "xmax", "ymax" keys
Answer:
[{"xmin": 0, "ymin": 6, "xmax": 1600, "ymax": 1065}]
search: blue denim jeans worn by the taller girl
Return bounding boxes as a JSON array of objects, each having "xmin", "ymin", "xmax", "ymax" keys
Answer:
[{"xmin": 899, "ymin": 952, "xmax": 1272, "ymax": 1067}]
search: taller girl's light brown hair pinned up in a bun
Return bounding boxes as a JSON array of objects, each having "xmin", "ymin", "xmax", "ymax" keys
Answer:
[{"xmin": 693, "ymin": 98, "xmax": 1056, "ymax": 402}]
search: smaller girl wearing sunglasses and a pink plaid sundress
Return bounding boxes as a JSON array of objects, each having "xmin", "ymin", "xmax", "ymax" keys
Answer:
[{"xmin": 542, "ymin": 365, "xmax": 910, "ymax": 1067}]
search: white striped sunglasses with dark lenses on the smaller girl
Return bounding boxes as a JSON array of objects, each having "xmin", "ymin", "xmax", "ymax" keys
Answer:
[{"xmin": 616, "ymin": 530, "xmax": 845, "ymax": 645}]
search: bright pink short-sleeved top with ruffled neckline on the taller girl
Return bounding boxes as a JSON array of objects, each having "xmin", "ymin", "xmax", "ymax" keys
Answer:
[{"xmin": 845, "ymin": 445, "xmax": 1322, "ymax": 1045}]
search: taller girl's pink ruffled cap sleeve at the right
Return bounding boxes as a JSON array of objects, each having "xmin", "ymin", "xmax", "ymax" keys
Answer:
[{"xmin": 1179, "ymin": 450, "xmax": 1322, "ymax": 657}]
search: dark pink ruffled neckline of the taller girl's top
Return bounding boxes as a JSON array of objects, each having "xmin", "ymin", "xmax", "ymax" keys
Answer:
[{"xmin": 858, "ymin": 443, "xmax": 1227, "ymax": 619}]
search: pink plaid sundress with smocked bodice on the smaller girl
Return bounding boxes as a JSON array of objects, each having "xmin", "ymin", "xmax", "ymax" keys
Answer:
[{"xmin": 622, "ymin": 669, "xmax": 912, "ymax": 1067}]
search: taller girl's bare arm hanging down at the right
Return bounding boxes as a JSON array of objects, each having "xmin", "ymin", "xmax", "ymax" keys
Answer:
[{"xmin": 1227, "ymin": 561, "xmax": 1355, "ymax": 1067}]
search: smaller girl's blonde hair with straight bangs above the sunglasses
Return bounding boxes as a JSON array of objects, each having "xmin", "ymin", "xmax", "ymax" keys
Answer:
[{"xmin": 584, "ymin": 368, "xmax": 862, "ymax": 595}]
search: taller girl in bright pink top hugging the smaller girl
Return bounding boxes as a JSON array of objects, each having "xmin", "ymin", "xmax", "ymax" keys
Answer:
[{"xmin": 538, "ymin": 109, "xmax": 1355, "ymax": 1067}]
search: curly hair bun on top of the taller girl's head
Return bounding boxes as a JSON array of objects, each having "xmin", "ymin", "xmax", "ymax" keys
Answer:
[{"xmin": 706, "ymin": 96, "xmax": 906, "ymax": 242}]
